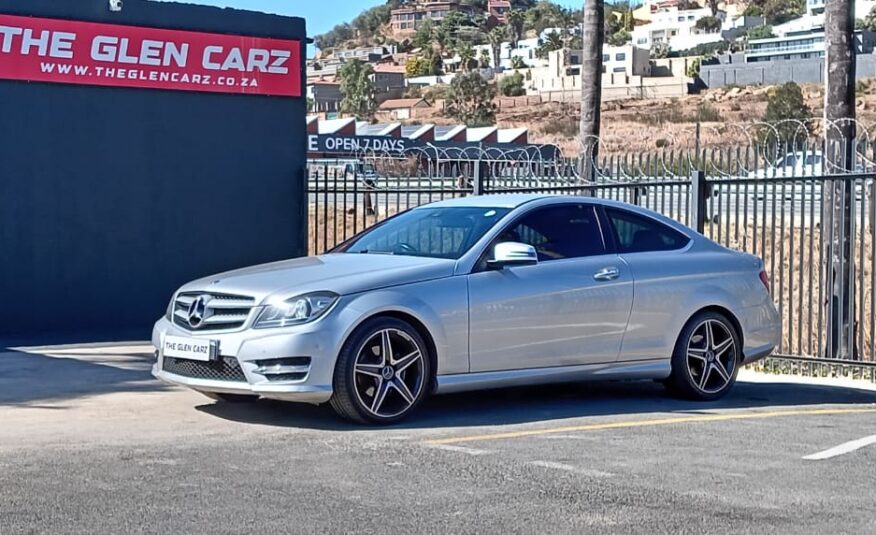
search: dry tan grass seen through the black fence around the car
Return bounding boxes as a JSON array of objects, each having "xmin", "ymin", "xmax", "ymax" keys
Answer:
[{"xmin": 308, "ymin": 205, "xmax": 876, "ymax": 361}]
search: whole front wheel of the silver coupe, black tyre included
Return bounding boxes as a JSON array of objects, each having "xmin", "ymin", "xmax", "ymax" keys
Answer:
[{"xmin": 329, "ymin": 317, "xmax": 432, "ymax": 424}]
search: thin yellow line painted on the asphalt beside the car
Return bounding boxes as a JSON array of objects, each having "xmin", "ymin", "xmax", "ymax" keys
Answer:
[{"xmin": 426, "ymin": 408, "xmax": 876, "ymax": 445}]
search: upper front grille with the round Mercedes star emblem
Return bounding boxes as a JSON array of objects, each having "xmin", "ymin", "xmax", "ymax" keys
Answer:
[{"xmin": 173, "ymin": 292, "xmax": 255, "ymax": 332}]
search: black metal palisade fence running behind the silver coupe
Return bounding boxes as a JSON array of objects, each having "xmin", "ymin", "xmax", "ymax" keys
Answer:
[{"xmin": 308, "ymin": 140, "xmax": 876, "ymax": 382}]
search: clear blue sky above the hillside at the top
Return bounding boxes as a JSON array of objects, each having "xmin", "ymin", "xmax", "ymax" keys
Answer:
[{"xmin": 163, "ymin": 0, "xmax": 584, "ymax": 42}]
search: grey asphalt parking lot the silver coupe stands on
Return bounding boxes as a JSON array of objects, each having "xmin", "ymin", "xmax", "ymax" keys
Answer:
[{"xmin": 0, "ymin": 347, "xmax": 876, "ymax": 534}]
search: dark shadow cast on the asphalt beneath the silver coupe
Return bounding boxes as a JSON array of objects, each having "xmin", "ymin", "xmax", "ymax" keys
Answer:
[{"xmin": 197, "ymin": 381, "xmax": 876, "ymax": 431}]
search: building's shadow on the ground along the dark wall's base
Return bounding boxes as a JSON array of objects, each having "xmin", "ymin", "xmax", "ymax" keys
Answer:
[{"xmin": 0, "ymin": 349, "xmax": 166, "ymax": 409}]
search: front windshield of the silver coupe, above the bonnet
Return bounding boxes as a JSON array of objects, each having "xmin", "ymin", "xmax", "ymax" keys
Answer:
[{"xmin": 335, "ymin": 206, "xmax": 510, "ymax": 260}]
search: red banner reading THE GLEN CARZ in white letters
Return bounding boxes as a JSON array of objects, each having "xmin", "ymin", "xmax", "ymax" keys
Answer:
[{"xmin": 0, "ymin": 14, "xmax": 301, "ymax": 97}]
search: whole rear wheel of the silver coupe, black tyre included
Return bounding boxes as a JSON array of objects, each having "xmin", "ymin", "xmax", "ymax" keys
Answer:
[{"xmin": 666, "ymin": 312, "xmax": 742, "ymax": 401}]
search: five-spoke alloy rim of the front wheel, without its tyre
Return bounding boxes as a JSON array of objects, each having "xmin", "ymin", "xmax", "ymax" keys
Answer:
[{"xmin": 353, "ymin": 328, "xmax": 425, "ymax": 418}]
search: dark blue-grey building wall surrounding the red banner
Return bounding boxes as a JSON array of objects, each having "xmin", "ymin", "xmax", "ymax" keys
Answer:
[{"xmin": 0, "ymin": 0, "xmax": 306, "ymax": 344}]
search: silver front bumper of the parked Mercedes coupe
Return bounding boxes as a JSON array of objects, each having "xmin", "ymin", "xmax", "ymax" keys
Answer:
[{"xmin": 152, "ymin": 318, "xmax": 341, "ymax": 404}]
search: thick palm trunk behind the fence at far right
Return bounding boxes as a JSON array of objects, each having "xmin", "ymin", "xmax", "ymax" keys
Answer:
[{"xmin": 821, "ymin": 0, "xmax": 858, "ymax": 359}]
